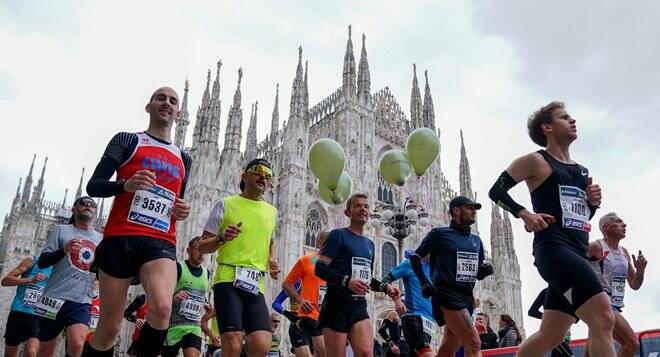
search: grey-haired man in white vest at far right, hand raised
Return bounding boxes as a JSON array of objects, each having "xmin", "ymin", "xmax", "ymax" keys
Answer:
[{"xmin": 590, "ymin": 212, "xmax": 647, "ymax": 357}]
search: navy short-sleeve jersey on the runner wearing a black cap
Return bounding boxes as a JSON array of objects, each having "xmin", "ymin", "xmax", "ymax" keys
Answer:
[{"xmin": 415, "ymin": 227, "xmax": 484, "ymax": 295}]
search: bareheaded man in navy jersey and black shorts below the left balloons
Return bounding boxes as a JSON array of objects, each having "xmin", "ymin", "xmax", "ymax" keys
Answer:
[{"xmin": 314, "ymin": 193, "xmax": 401, "ymax": 357}]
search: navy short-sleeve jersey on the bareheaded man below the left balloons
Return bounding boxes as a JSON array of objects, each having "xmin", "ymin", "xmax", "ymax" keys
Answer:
[{"xmin": 319, "ymin": 228, "xmax": 374, "ymax": 297}]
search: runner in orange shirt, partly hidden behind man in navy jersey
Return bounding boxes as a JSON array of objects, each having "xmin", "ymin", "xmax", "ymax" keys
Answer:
[{"xmin": 282, "ymin": 231, "xmax": 330, "ymax": 357}]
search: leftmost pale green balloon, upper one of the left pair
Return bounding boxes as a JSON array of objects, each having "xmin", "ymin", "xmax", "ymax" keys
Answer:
[{"xmin": 307, "ymin": 138, "xmax": 346, "ymax": 190}]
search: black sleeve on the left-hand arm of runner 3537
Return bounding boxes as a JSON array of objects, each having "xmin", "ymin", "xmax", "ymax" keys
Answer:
[{"xmin": 87, "ymin": 133, "xmax": 138, "ymax": 197}]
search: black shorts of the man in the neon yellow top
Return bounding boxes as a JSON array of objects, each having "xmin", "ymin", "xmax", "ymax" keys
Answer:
[{"xmin": 213, "ymin": 283, "xmax": 271, "ymax": 334}]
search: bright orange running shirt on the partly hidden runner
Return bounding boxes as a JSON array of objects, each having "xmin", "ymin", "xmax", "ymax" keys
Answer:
[{"xmin": 286, "ymin": 253, "xmax": 326, "ymax": 320}]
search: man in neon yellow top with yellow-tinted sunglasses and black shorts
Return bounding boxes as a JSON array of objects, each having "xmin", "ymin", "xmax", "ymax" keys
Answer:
[{"xmin": 199, "ymin": 159, "xmax": 280, "ymax": 357}]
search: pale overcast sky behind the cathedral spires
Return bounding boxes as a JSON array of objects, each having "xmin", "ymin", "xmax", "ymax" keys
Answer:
[{"xmin": 0, "ymin": 0, "xmax": 660, "ymax": 337}]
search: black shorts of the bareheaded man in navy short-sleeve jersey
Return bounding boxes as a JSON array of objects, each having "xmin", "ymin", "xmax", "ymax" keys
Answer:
[{"xmin": 318, "ymin": 296, "xmax": 369, "ymax": 333}]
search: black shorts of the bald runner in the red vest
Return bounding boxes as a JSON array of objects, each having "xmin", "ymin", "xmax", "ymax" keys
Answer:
[{"xmin": 94, "ymin": 236, "xmax": 176, "ymax": 279}]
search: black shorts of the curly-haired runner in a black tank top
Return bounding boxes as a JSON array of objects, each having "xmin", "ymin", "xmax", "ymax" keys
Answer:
[{"xmin": 534, "ymin": 244, "xmax": 603, "ymax": 317}]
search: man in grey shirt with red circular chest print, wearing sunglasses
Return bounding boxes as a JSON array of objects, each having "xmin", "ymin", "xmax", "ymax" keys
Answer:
[{"xmin": 34, "ymin": 196, "xmax": 101, "ymax": 356}]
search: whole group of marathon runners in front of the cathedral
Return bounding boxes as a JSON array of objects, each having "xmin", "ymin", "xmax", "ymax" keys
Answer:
[{"xmin": 2, "ymin": 87, "xmax": 646, "ymax": 357}]
